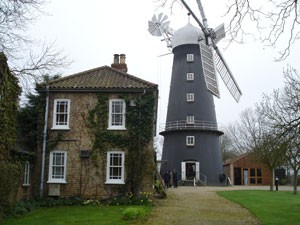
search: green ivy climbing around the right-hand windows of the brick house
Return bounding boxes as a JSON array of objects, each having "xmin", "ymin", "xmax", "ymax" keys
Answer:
[{"xmin": 87, "ymin": 92, "xmax": 156, "ymax": 193}]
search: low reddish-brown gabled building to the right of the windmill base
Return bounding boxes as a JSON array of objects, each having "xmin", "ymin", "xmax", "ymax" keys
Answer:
[{"xmin": 223, "ymin": 153, "xmax": 271, "ymax": 185}]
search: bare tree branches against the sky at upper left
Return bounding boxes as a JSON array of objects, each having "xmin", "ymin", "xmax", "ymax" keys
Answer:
[{"xmin": 0, "ymin": 0, "xmax": 70, "ymax": 91}]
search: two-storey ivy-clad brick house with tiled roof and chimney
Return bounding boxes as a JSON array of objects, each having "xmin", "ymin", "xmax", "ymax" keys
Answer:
[{"xmin": 36, "ymin": 54, "xmax": 158, "ymax": 199}]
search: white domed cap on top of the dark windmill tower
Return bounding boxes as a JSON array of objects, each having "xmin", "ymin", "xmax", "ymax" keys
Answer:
[{"xmin": 172, "ymin": 22, "xmax": 204, "ymax": 49}]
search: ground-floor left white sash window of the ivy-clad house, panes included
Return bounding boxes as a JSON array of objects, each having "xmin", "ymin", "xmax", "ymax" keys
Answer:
[{"xmin": 48, "ymin": 150, "xmax": 67, "ymax": 183}]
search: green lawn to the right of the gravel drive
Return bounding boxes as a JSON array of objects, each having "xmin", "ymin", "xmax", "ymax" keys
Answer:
[{"xmin": 218, "ymin": 190, "xmax": 300, "ymax": 225}]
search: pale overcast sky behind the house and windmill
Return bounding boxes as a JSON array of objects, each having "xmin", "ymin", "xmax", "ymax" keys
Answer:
[{"xmin": 30, "ymin": 0, "xmax": 300, "ymax": 130}]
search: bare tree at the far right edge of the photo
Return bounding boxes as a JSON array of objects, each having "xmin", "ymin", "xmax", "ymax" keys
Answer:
[{"xmin": 258, "ymin": 67, "xmax": 300, "ymax": 194}]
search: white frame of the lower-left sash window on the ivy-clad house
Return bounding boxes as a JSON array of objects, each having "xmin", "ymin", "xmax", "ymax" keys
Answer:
[{"xmin": 48, "ymin": 150, "xmax": 67, "ymax": 184}]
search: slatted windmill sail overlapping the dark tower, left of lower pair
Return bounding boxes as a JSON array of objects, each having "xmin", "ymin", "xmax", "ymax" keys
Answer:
[{"xmin": 199, "ymin": 43, "xmax": 220, "ymax": 98}]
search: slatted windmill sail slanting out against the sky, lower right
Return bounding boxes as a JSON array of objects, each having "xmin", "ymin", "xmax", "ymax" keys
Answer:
[{"xmin": 214, "ymin": 46, "xmax": 242, "ymax": 102}]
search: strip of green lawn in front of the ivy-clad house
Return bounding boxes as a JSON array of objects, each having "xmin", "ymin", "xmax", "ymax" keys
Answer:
[{"xmin": 4, "ymin": 206, "xmax": 151, "ymax": 225}]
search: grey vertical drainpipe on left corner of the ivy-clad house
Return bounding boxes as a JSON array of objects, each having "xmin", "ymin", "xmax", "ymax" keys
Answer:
[{"xmin": 40, "ymin": 83, "xmax": 49, "ymax": 198}]
